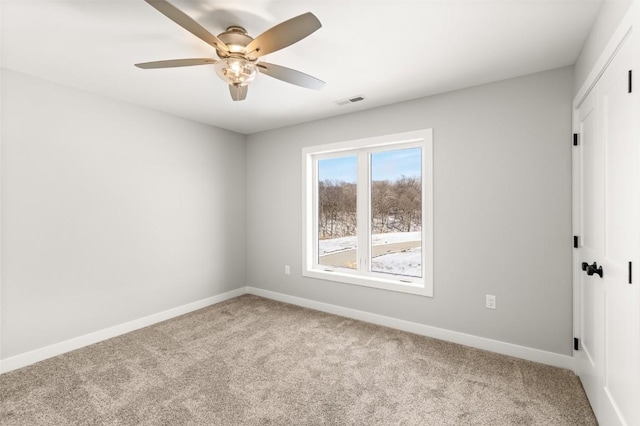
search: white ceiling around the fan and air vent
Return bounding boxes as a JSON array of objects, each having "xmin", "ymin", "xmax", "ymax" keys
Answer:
[{"xmin": 1, "ymin": 0, "xmax": 601, "ymax": 134}]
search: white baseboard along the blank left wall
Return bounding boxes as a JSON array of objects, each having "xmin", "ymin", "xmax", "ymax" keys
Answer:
[{"xmin": 0, "ymin": 287, "xmax": 247, "ymax": 373}]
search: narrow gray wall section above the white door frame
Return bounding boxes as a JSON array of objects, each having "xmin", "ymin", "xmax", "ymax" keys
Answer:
[{"xmin": 573, "ymin": 0, "xmax": 634, "ymax": 95}]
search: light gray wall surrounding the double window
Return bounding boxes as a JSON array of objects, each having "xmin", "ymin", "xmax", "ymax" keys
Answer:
[{"xmin": 246, "ymin": 68, "xmax": 573, "ymax": 355}]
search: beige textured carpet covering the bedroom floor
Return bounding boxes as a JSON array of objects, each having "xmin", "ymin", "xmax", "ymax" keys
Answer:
[{"xmin": 0, "ymin": 295, "xmax": 596, "ymax": 426}]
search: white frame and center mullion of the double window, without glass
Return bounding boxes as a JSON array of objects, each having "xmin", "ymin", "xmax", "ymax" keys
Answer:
[{"xmin": 302, "ymin": 129, "xmax": 433, "ymax": 297}]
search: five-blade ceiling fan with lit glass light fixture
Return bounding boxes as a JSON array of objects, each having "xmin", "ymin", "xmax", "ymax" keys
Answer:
[{"xmin": 135, "ymin": 0, "xmax": 324, "ymax": 101}]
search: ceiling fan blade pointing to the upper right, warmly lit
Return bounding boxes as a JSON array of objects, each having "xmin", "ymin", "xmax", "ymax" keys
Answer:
[{"xmin": 245, "ymin": 12, "xmax": 322, "ymax": 59}]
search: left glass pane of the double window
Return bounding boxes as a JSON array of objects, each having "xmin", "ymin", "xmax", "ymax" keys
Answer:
[{"xmin": 318, "ymin": 156, "xmax": 358, "ymax": 269}]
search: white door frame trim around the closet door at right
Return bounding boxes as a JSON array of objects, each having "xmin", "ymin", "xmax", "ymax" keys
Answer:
[{"xmin": 571, "ymin": 1, "xmax": 640, "ymax": 373}]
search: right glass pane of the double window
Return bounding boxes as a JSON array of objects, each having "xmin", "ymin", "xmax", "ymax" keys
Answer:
[{"xmin": 370, "ymin": 148, "xmax": 422, "ymax": 277}]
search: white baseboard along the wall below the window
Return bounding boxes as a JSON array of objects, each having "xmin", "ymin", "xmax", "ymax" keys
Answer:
[{"xmin": 246, "ymin": 287, "xmax": 575, "ymax": 371}]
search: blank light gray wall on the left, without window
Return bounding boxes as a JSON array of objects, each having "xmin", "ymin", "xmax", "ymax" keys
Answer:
[{"xmin": 1, "ymin": 70, "xmax": 245, "ymax": 359}]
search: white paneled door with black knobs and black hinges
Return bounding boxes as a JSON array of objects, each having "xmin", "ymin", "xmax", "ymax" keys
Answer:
[{"xmin": 574, "ymin": 32, "xmax": 640, "ymax": 426}]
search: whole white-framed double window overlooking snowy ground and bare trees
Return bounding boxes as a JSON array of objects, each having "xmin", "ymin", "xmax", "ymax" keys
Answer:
[{"xmin": 302, "ymin": 129, "xmax": 433, "ymax": 296}]
